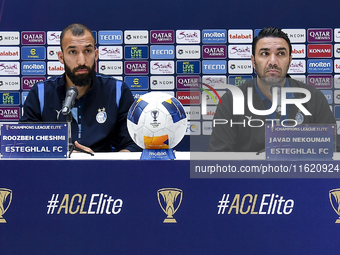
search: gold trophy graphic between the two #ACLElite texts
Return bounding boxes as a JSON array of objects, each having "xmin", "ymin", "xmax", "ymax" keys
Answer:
[{"xmin": 157, "ymin": 188, "xmax": 183, "ymax": 223}]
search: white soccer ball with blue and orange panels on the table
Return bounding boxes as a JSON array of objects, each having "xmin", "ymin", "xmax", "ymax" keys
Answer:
[{"xmin": 127, "ymin": 92, "xmax": 187, "ymax": 149}]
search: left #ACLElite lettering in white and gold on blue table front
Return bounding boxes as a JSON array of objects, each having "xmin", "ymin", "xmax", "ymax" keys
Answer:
[{"xmin": 47, "ymin": 193, "xmax": 123, "ymax": 215}]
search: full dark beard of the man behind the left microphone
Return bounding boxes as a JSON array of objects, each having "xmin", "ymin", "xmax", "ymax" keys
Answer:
[{"xmin": 64, "ymin": 63, "xmax": 95, "ymax": 87}]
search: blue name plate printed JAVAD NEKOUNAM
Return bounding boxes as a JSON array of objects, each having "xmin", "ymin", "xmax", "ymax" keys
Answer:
[{"xmin": 266, "ymin": 125, "xmax": 336, "ymax": 160}]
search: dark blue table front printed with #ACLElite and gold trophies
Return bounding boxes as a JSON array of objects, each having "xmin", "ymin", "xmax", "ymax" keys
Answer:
[{"xmin": 0, "ymin": 160, "xmax": 340, "ymax": 254}]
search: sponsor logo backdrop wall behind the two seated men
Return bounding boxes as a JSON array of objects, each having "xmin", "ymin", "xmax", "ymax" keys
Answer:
[{"xmin": 0, "ymin": 0, "xmax": 340, "ymax": 150}]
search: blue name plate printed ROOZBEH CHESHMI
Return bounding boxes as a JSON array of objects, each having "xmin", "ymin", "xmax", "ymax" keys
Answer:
[{"xmin": 1, "ymin": 123, "xmax": 67, "ymax": 158}]
